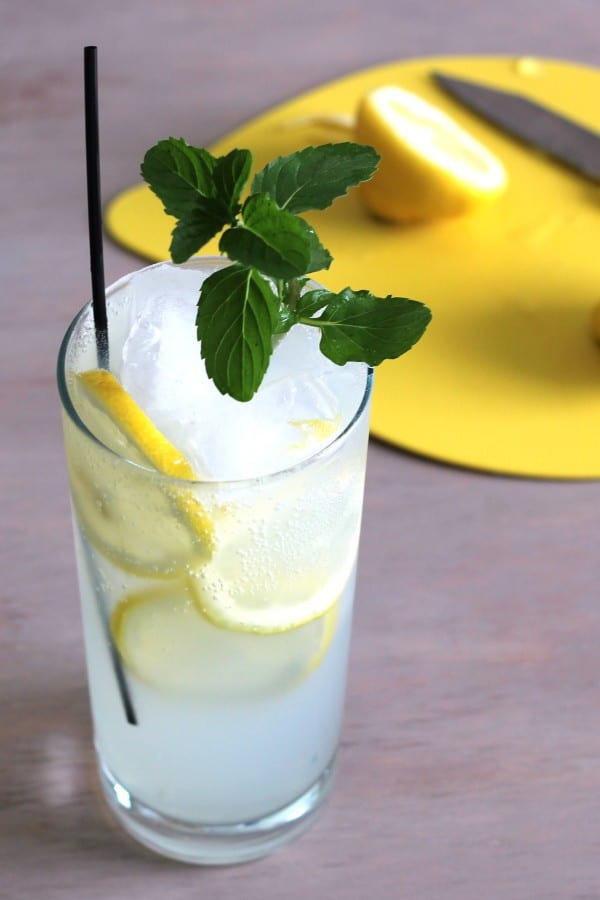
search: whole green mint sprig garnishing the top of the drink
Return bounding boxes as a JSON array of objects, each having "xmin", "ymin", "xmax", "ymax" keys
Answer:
[{"xmin": 142, "ymin": 138, "xmax": 431, "ymax": 401}]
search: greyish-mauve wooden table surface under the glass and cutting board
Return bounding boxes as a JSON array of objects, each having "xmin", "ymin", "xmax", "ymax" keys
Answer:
[{"xmin": 0, "ymin": 0, "xmax": 600, "ymax": 900}]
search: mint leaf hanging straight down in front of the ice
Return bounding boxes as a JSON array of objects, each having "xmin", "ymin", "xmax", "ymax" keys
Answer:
[{"xmin": 196, "ymin": 265, "xmax": 278, "ymax": 401}]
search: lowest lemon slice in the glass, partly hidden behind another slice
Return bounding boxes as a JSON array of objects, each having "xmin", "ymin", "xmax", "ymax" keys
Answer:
[{"xmin": 111, "ymin": 581, "xmax": 337, "ymax": 702}]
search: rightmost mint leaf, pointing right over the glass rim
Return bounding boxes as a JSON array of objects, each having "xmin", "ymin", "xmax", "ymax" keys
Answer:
[{"xmin": 301, "ymin": 288, "xmax": 431, "ymax": 366}]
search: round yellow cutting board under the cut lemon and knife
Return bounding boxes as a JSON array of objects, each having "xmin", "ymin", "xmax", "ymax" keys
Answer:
[{"xmin": 105, "ymin": 57, "xmax": 600, "ymax": 478}]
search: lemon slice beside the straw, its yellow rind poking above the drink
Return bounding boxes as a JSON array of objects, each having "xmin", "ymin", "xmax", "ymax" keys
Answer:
[{"xmin": 66, "ymin": 369, "xmax": 215, "ymax": 577}]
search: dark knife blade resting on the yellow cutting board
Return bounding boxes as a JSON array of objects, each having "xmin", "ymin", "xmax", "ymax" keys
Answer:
[{"xmin": 431, "ymin": 72, "xmax": 600, "ymax": 182}]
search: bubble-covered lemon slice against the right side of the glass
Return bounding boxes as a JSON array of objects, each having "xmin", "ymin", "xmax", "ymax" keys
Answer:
[{"xmin": 189, "ymin": 448, "xmax": 362, "ymax": 635}]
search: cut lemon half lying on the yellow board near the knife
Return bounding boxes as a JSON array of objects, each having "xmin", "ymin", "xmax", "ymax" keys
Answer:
[{"xmin": 355, "ymin": 86, "xmax": 507, "ymax": 222}]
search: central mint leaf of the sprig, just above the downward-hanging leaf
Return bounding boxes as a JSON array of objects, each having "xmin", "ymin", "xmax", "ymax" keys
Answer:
[{"xmin": 219, "ymin": 194, "xmax": 315, "ymax": 279}]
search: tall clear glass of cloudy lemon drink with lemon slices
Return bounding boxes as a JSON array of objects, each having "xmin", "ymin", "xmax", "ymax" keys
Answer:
[{"xmin": 58, "ymin": 257, "xmax": 372, "ymax": 864}]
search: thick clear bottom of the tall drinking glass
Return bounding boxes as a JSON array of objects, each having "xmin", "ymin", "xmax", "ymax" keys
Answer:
[{"xmin": 98, "ymin": 758, "xmax": 335, "ymax": 866}]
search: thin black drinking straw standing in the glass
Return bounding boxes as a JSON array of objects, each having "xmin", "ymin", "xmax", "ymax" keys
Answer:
[{"xmin": 83, "ymin": 47, "xmax": 137, "ymax": 725}]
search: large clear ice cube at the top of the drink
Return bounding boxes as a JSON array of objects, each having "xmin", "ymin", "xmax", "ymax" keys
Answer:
[{"xmin": 117, "ymin": 264, "xmax": 364, "ymax": 479}]
